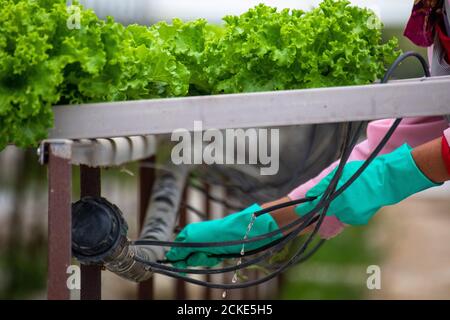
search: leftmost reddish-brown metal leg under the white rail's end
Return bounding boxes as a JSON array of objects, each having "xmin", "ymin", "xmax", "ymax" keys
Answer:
[{"xmin": 47, "ymin": 143, "xmax": 72, "ymax": 300}]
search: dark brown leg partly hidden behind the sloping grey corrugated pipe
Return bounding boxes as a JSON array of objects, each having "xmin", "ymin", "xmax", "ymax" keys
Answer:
[{"xmin": 138, "ymin": 157, "xmax": 155, "ymax": 300}]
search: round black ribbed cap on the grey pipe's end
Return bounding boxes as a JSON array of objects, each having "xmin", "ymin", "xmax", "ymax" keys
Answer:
[{"xmin": 72, "ymin": 197, "xmax": 123, "ymax": 257}]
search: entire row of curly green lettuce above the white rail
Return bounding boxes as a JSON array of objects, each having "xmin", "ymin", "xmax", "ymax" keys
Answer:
[{"xmin": 0, "ymin": 0, "xmax": 399, "ymax": 150}]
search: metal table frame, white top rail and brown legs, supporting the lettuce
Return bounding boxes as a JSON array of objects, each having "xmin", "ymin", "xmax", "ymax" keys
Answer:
[{"xmin": 41, "ymin": 77, "xmax": 450, "ymax": 299}]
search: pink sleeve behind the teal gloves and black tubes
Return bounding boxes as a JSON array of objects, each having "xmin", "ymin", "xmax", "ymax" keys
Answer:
[{"xmin": 288, "ymin": 117, "xmax": 448, "ymax": 200}]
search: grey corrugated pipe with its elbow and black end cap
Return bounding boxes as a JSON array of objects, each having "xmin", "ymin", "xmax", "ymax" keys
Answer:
[{"xmin": 72, "ymin": 164, "xmax": 188, "ymax": 282}]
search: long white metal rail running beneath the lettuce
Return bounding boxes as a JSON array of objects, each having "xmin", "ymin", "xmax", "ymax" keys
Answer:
[{"xmin": 50, "ymin": 77, "xmax": 450, "ymax": 139}]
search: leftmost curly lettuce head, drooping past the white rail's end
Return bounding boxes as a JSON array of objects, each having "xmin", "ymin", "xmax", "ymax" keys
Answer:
[{"xmin": 0, "ymin": 0, "xmax": 64, "ymax": 150}]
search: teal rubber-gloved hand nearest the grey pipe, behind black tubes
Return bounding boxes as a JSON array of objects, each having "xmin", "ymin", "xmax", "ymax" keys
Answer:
[{"xmin": 166, "ymin": 204, "xmax": 282, "ymax": 268}]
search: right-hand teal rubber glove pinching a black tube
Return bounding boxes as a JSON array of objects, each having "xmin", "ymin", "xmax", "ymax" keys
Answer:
[{"xmin": 295, "ymin": 144, "xmax": 440, "ymax": 225}]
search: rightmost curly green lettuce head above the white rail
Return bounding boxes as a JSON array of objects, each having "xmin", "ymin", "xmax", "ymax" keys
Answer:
[{"xmin": 204, "ymin": 0, "xmax": 399, "ymax": 93}]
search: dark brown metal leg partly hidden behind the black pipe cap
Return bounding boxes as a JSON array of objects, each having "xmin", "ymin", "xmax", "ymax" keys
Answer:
[{"xmin": 80, "ymin": 165, "xmax": 102, "ymax": 300}]
